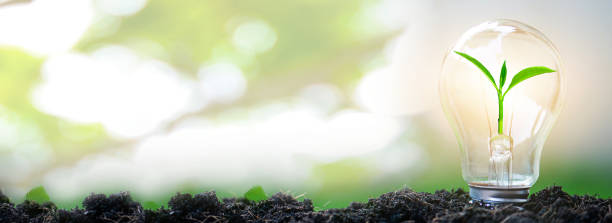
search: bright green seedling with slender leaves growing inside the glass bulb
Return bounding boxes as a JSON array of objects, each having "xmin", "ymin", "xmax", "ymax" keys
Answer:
[{"xmin": 455, "ymin": 51, "xmax": 555, "ymax": 134}]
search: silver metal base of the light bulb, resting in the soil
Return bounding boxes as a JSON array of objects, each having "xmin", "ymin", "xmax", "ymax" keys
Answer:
[{"xmin": 469, "ymin": 185, "xmax": 529, "ymax": 204}]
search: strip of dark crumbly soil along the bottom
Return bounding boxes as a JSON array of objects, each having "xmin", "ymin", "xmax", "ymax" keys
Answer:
[{"xmin": 0, "ymin": 187, "xmax": 612, "ymax": 222}]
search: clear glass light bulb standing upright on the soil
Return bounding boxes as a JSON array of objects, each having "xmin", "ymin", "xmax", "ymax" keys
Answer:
[{"xmin": 440, "ymin": 20, "xmax": 565, "ymax": 203}]
